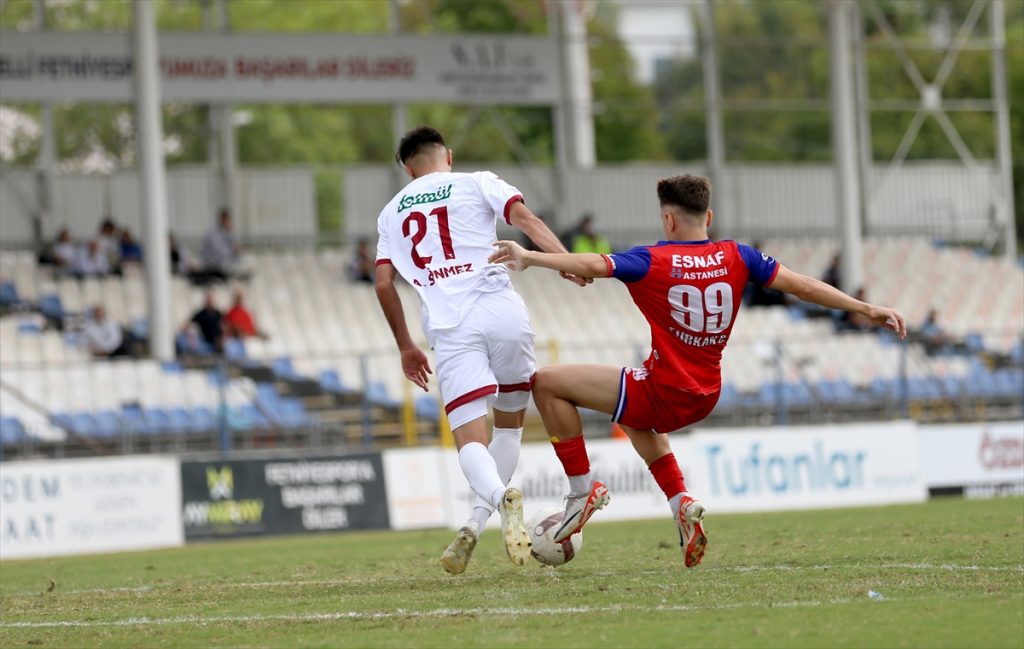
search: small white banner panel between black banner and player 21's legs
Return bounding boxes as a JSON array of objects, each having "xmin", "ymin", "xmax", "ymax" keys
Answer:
[{"xmin": 382, "ymin": 448, "xmax": 448, "ymax": 529}]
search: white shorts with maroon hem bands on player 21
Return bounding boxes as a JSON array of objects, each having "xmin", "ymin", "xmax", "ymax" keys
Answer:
[{"xmin": 432, "ymin": 289, "xmax": 537, "ymax": 430}]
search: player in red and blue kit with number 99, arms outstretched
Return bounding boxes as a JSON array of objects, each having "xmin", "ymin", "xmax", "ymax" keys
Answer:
[{"xmin": 490, "ymin": 175, "xmax": 906, "ymax": 567}]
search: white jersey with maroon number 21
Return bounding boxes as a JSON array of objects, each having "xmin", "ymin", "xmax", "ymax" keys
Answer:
[{"xmin": 377, "ymin": 171, "xmax": 522, "ymax": 335}]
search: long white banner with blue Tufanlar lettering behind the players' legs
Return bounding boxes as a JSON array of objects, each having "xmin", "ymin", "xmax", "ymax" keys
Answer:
[{"xmin": 432, "ymin": 423, "xmax": 928, "ymax": 528}]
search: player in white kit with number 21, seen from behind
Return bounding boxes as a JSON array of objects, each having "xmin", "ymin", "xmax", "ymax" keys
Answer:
[{"xmin": 375, "ymin": 126, "xmax": 586, "ymax": 574}]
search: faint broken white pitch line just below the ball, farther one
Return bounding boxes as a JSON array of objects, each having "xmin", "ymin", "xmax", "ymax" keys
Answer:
[{"xmin": 3, "ymin": 563, "xmax": 1024, "ymax": 597}]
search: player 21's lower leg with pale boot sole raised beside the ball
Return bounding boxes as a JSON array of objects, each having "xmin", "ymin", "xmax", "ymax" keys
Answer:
[{"xmin": 452, "ymin": 417, "xmax": 530, "ymax": 566}]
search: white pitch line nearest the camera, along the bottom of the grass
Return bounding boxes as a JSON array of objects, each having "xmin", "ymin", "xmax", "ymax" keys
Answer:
[{"xmin": 0, "ymin": 599, "xmax": 854, "ymax": 629}]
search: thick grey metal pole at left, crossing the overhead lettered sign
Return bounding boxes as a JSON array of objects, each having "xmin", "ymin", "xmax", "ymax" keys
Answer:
[{"xmin": 132, "ymin": 0, "xmax": 174, "ymax": 360}]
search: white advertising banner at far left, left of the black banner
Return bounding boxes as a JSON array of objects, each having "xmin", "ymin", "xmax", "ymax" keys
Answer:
[{"xmin": 0, "ymin": 457, "xmax": 184, "ymax": 559}]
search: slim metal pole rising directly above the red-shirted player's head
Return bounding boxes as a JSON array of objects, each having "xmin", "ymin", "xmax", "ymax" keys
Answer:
[{"xmin": 700, "ymin": 0, "xmax": 740, "ymax": 239}]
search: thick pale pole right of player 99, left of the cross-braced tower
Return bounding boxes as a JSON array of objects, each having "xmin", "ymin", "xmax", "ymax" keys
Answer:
[{"xmin": 828, "ymin": 0, "xmax": 864, "ymax": 293}]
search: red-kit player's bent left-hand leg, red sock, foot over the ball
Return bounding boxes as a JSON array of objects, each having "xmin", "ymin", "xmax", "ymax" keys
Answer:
[{"xmin": 534, "ymin": 365, "xmax": 622, "ymax": 542}]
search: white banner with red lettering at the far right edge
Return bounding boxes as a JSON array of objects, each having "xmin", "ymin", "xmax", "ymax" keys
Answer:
[{"xmin": 918, "ymin": 422, "xmax": 1024, "ymax": 496}]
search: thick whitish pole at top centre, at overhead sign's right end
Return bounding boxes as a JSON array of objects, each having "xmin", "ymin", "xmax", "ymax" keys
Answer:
[{"xmin": 556, "ymin": 2, "xmax": 597, "ymax": 169}]
